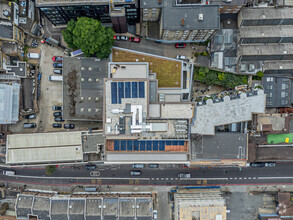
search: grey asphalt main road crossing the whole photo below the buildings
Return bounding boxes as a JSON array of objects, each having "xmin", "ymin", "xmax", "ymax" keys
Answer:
[{"xmin": 0, "ymin": 163, "xmax": 293, "ymax": 185}]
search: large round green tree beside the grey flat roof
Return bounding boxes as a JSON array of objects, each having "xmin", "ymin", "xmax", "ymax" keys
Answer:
[{"xmin": 62, "ymin": 17, "xmax": 114, "ymax": 59}]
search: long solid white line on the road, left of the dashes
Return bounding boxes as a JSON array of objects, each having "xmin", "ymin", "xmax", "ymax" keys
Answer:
[{"xmin": 11, "ymin": 175, "xmax": 150, "ymax": 180}]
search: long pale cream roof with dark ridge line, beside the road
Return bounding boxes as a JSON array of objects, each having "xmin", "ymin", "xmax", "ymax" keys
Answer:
[{"xmin": 6, "ymin": 132, "xmax": 83, "ymax": 164}]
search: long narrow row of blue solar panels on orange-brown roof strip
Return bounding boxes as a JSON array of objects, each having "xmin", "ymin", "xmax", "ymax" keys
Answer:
[{"xmin": 114, "ymin": 140, "xmax": 184, "ymax": 151}]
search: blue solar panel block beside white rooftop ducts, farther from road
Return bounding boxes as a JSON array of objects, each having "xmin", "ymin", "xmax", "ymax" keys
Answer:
[{"xmin": 111, "ymin": 82, "xmax": 145, "ymax": 104}]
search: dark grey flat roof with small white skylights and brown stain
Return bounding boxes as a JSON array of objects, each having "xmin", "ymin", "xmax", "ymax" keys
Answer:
[{"xmin": 63, "ymin": 57, "xmax": 108, "ymax": 121}]
